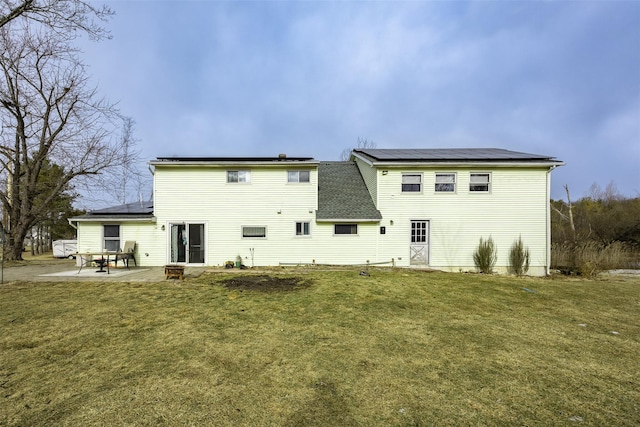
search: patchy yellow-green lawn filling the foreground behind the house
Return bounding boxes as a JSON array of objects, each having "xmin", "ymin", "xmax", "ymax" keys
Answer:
[{"xmin": 0, "ymin": 269, "xmax": 640, "ymax": 426}]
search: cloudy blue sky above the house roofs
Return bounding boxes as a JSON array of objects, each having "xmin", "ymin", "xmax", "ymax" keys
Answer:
[{"xmin": 81, "ymin": 1, "xmax": 640, "ymax": 199}]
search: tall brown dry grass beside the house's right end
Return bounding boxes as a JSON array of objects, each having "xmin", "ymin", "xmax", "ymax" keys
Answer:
[{"xmin": 551, "ymin": 242, "xmax": 639, "ymax": 276}]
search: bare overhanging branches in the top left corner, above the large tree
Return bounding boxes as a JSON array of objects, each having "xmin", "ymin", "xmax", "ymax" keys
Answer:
[{"xmin": 0, "ymin": 0, "xmax": 113, "ymax": 40}]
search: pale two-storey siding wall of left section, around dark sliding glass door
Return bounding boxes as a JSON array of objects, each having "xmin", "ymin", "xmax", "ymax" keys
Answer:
[{"xmin": 154, "ymin": 165, "xmax": 318, "ymax": 266}]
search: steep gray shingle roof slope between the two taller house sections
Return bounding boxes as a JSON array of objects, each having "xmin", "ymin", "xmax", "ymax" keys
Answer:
[{"xmin": 316, "ymin": 162, "xmax": 382, "ymax": 221}]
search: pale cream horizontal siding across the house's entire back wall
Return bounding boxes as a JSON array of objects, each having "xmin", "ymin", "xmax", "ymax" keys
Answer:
[{"xmin": 78, "ymin": 162, "xmax": 548, "ymax": 275}]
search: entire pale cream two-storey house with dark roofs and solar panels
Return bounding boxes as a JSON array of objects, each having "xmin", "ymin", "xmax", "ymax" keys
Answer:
[{"xmin": 70, "ymin": 149, "xmax": 563, "ymax": 275}]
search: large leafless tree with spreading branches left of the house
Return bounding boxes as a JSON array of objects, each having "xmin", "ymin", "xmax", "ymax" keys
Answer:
[{"xmin": 0, "ymin": 24, "xmax": 123, "ymax": 259}]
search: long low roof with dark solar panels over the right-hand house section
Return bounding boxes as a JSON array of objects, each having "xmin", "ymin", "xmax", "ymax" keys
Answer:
[{"xmin": 354, "ymin": 148, "xmax": 556, "ymax": 162}]
